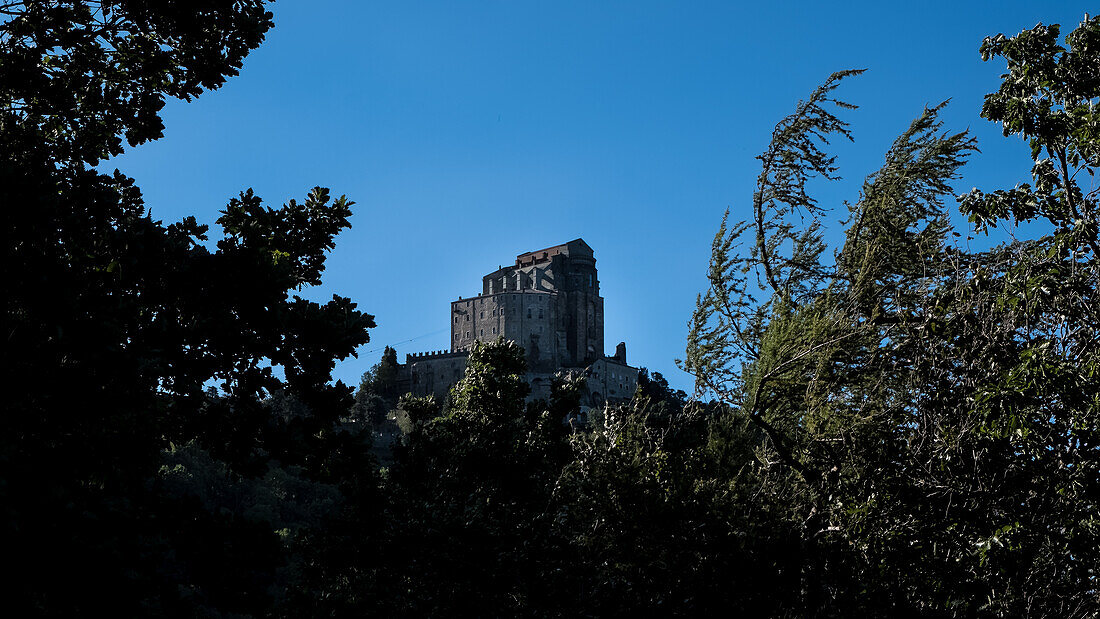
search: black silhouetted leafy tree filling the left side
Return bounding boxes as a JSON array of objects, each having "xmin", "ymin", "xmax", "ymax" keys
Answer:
[{"xmin": 0, "ymin": 0, "xmax": 373, "ymax": 615}]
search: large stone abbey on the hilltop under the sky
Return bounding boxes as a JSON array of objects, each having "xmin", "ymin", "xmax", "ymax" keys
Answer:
[{"xmin": 399, "ymin": 239, "xmax": 638, "ymax": 407}]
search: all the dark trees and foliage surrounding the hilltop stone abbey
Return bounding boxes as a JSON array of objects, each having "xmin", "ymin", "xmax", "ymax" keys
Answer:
[{"xmin": 0, "ymin": 0, "xmax": 1100, "ymax": 617}]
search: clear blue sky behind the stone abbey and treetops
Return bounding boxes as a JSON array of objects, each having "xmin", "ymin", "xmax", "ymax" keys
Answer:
[{"xmin": 105, "ymin": 0, "xmax": 1096, "ymax": 390}]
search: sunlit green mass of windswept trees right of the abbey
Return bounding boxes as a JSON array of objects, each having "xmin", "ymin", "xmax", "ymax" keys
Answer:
[{"xmin": 684, "ymin": 14, "xmax": 1100, "ymax": 617}]
